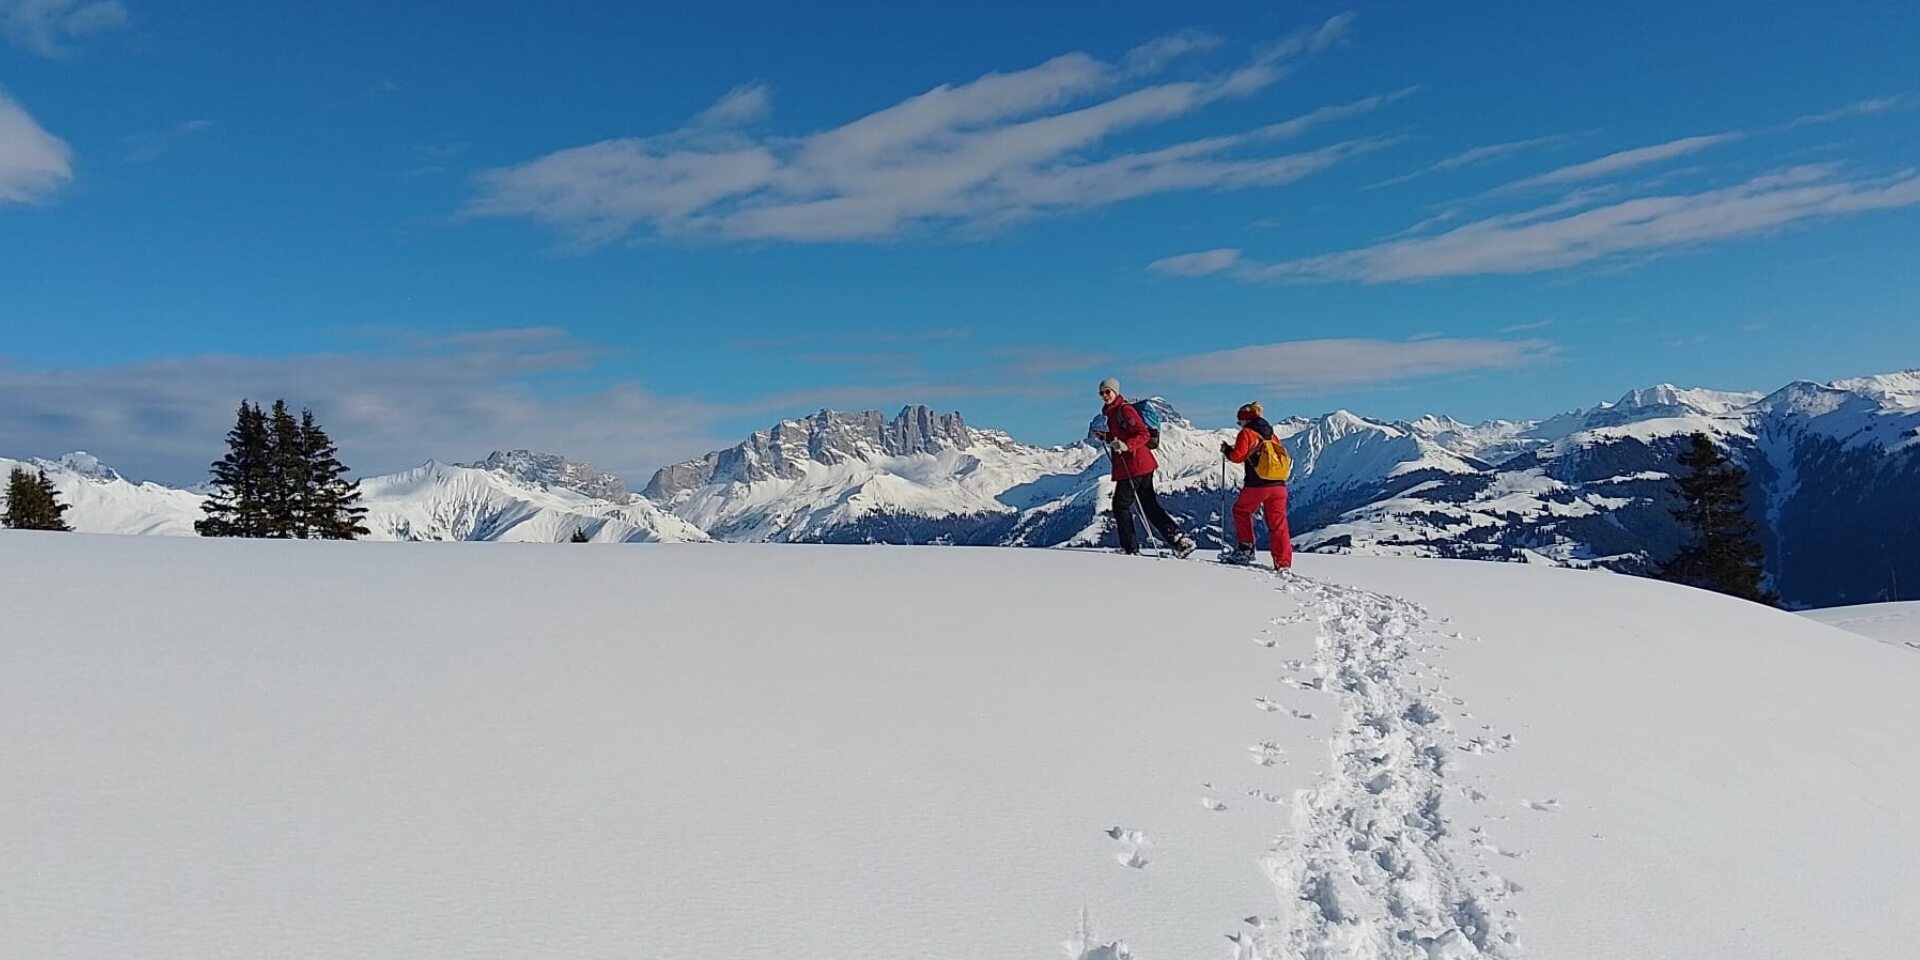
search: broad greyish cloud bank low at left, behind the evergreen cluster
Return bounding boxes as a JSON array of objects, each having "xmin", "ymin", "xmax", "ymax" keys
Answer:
[{"xmin": 0, "ymin": 328, "xmax": 728, "ymax": 486}]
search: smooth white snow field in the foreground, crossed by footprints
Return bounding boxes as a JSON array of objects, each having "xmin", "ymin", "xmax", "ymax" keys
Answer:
[{"xmin": 0, "ymin": 534, "xmax": 1920, "ymax": 960}]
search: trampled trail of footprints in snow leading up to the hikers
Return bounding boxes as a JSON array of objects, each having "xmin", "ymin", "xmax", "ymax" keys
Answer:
[{"xmin": 1235, "ymin": 572, "xmax": 1523, "ymax": 960}]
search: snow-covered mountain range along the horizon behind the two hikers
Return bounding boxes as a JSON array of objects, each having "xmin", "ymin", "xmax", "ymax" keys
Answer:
[{"xmin": 0, "ymin": 371, "xmax": 1920, "ymax": 607}]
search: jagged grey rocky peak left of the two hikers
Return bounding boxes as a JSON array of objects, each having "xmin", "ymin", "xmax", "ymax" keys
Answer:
[{"xmin": 645, "ymin": 405, "xmax": 975, "ymax": 501}]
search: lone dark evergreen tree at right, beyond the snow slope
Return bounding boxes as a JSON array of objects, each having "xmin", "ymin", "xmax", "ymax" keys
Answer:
[{"xmin": 1655, "ymin": 434, "xmax": 1780, "ymax": 605}]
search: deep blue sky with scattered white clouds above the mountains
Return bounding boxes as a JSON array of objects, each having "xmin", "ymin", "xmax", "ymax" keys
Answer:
[{"xmin": 0, "ymin": 0, "xmax": 1920, "ymax": 484}]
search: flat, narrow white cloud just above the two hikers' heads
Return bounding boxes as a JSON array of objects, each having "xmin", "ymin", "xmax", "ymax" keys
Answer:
[{"xmin": 1129, "ymin": 338, "xmax": 1555, "ymax": 394}]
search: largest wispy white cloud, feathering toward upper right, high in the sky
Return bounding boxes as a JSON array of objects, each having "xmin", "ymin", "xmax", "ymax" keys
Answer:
[{"xmin": 467, "ymin": 15, "xmax": 1405, "ymax": 244}]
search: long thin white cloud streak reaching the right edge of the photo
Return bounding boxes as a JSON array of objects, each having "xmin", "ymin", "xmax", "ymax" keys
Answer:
[{"xmin": 1190, "ymin": 165, "xmax": 1920, "ymax": 282}]
